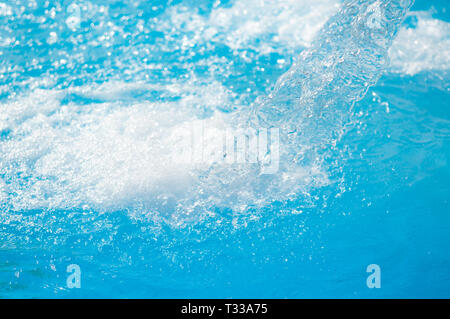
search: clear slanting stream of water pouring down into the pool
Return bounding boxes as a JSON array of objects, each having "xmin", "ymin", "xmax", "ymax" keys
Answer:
[{"xmin": 251, "ymin": 0, "xmax": 413, "ymax": 141}]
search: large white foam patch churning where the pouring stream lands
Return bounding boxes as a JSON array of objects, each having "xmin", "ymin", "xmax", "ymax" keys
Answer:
[{"xmin": 0, "ymin": 83, "xmax": 328, "ymax": 222}]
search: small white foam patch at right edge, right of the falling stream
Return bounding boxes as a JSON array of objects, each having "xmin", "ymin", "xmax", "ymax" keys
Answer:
[{"xmin": 389, "ymin": 12, "xmax": 450, "ymax": 75}]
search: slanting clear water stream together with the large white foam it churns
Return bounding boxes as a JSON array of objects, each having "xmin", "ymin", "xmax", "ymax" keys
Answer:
[{"xmin": 0, "ymin": 1, "xmax": 411, "ymax": 226}]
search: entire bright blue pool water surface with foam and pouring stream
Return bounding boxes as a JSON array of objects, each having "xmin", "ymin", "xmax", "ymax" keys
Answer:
[{"xmin": 0, "ymin": 0, "xmax": 450, "ymax": 298}]
